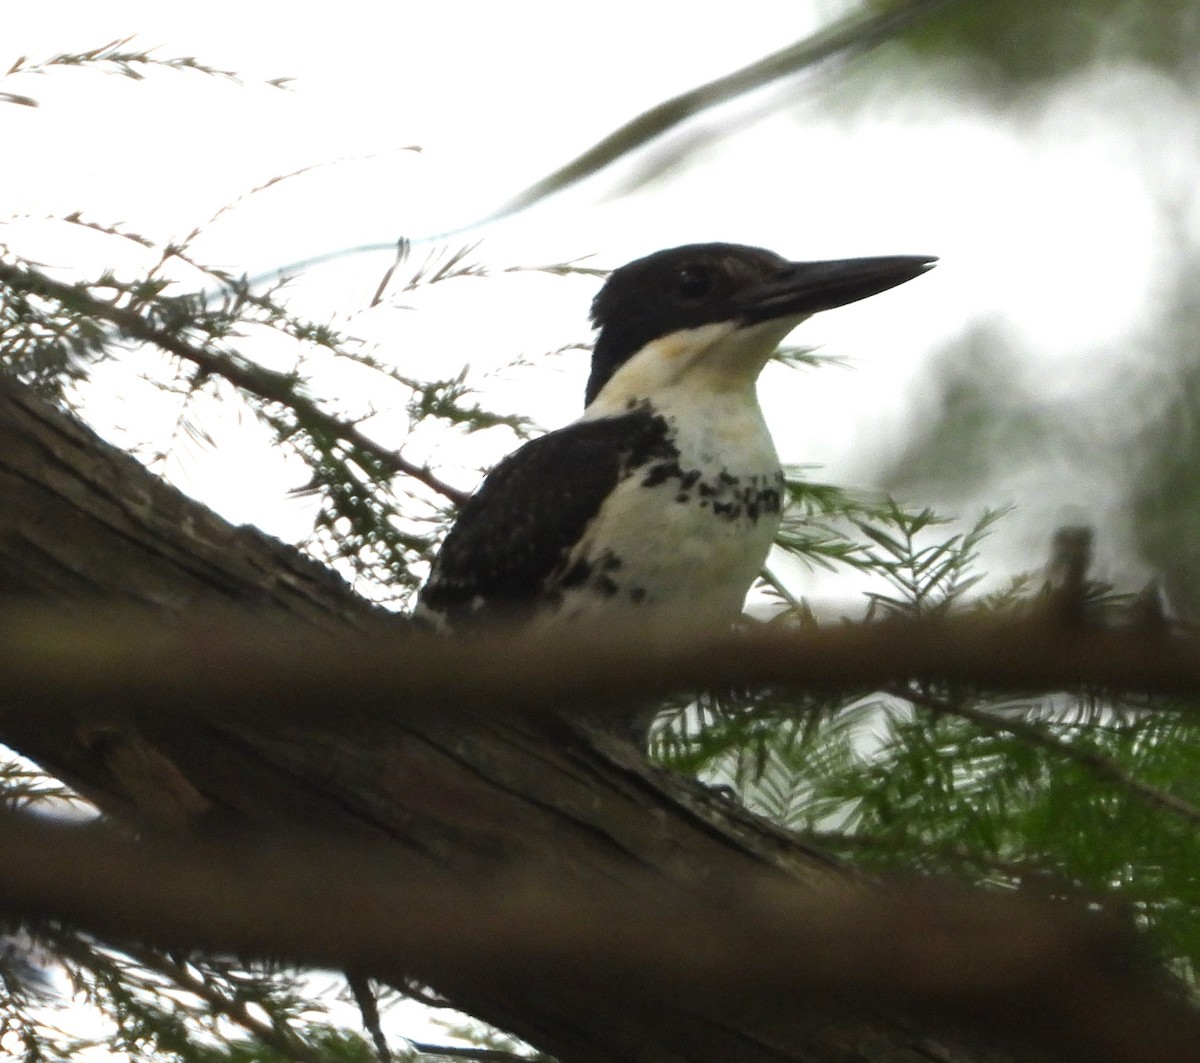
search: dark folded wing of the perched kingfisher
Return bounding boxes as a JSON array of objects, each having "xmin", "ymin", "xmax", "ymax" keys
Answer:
[{"xmin": 419, "ymin": 410, "xmax": 676, "ymax": 629}]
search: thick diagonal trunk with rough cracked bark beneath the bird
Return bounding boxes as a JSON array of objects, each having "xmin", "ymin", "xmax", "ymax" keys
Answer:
[{"xmin": 0, "ymin": 385, "xmax": 1192, "ymax": 1063}]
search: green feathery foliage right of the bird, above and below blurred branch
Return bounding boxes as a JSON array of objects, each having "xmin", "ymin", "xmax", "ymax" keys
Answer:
[{"xmin": 656, "ymin": 494, "xmax": 1200, "ymax": 980}]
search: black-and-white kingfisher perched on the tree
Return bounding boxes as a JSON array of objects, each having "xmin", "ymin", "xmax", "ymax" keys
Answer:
[{"xmin": 415, "ymin": 244, "xmax": 936, "ymax": 715}]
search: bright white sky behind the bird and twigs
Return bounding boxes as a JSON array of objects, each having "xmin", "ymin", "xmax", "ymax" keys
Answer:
[{"xmin": 0, "ymin": 0, "xmax": 1200, "ymax": 1055}]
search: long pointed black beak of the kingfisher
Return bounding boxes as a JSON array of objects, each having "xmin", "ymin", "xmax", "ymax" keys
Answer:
[{"xmin": 734, "ymin": 254, "xmax": 937, "ymax": 324}]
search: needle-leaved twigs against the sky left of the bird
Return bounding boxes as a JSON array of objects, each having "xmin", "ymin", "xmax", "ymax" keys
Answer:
[{"xmin": 0, "ymin": 223, "xmax": 590, "ymax": 602}]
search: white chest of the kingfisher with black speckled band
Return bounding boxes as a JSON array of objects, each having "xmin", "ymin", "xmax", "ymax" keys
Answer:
[{"xmin": 562, "ymin": 404, "xmax": 784, "ymax": 620}]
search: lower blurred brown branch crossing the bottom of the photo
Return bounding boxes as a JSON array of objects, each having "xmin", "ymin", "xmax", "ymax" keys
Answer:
[{"xmin": 0, "ymin": 816, "xmax": 1200, "ymax": 1063}]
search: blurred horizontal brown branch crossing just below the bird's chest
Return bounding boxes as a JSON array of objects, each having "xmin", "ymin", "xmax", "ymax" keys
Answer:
[{"xmin": 0, "ymin": 607, "xmax": 1200, "ymax": 724}]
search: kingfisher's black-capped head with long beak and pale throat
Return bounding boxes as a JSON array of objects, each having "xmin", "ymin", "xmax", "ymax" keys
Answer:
[{"xmin": 586, "ymin": 244, "xmax": 936, "ymax": 406}]
